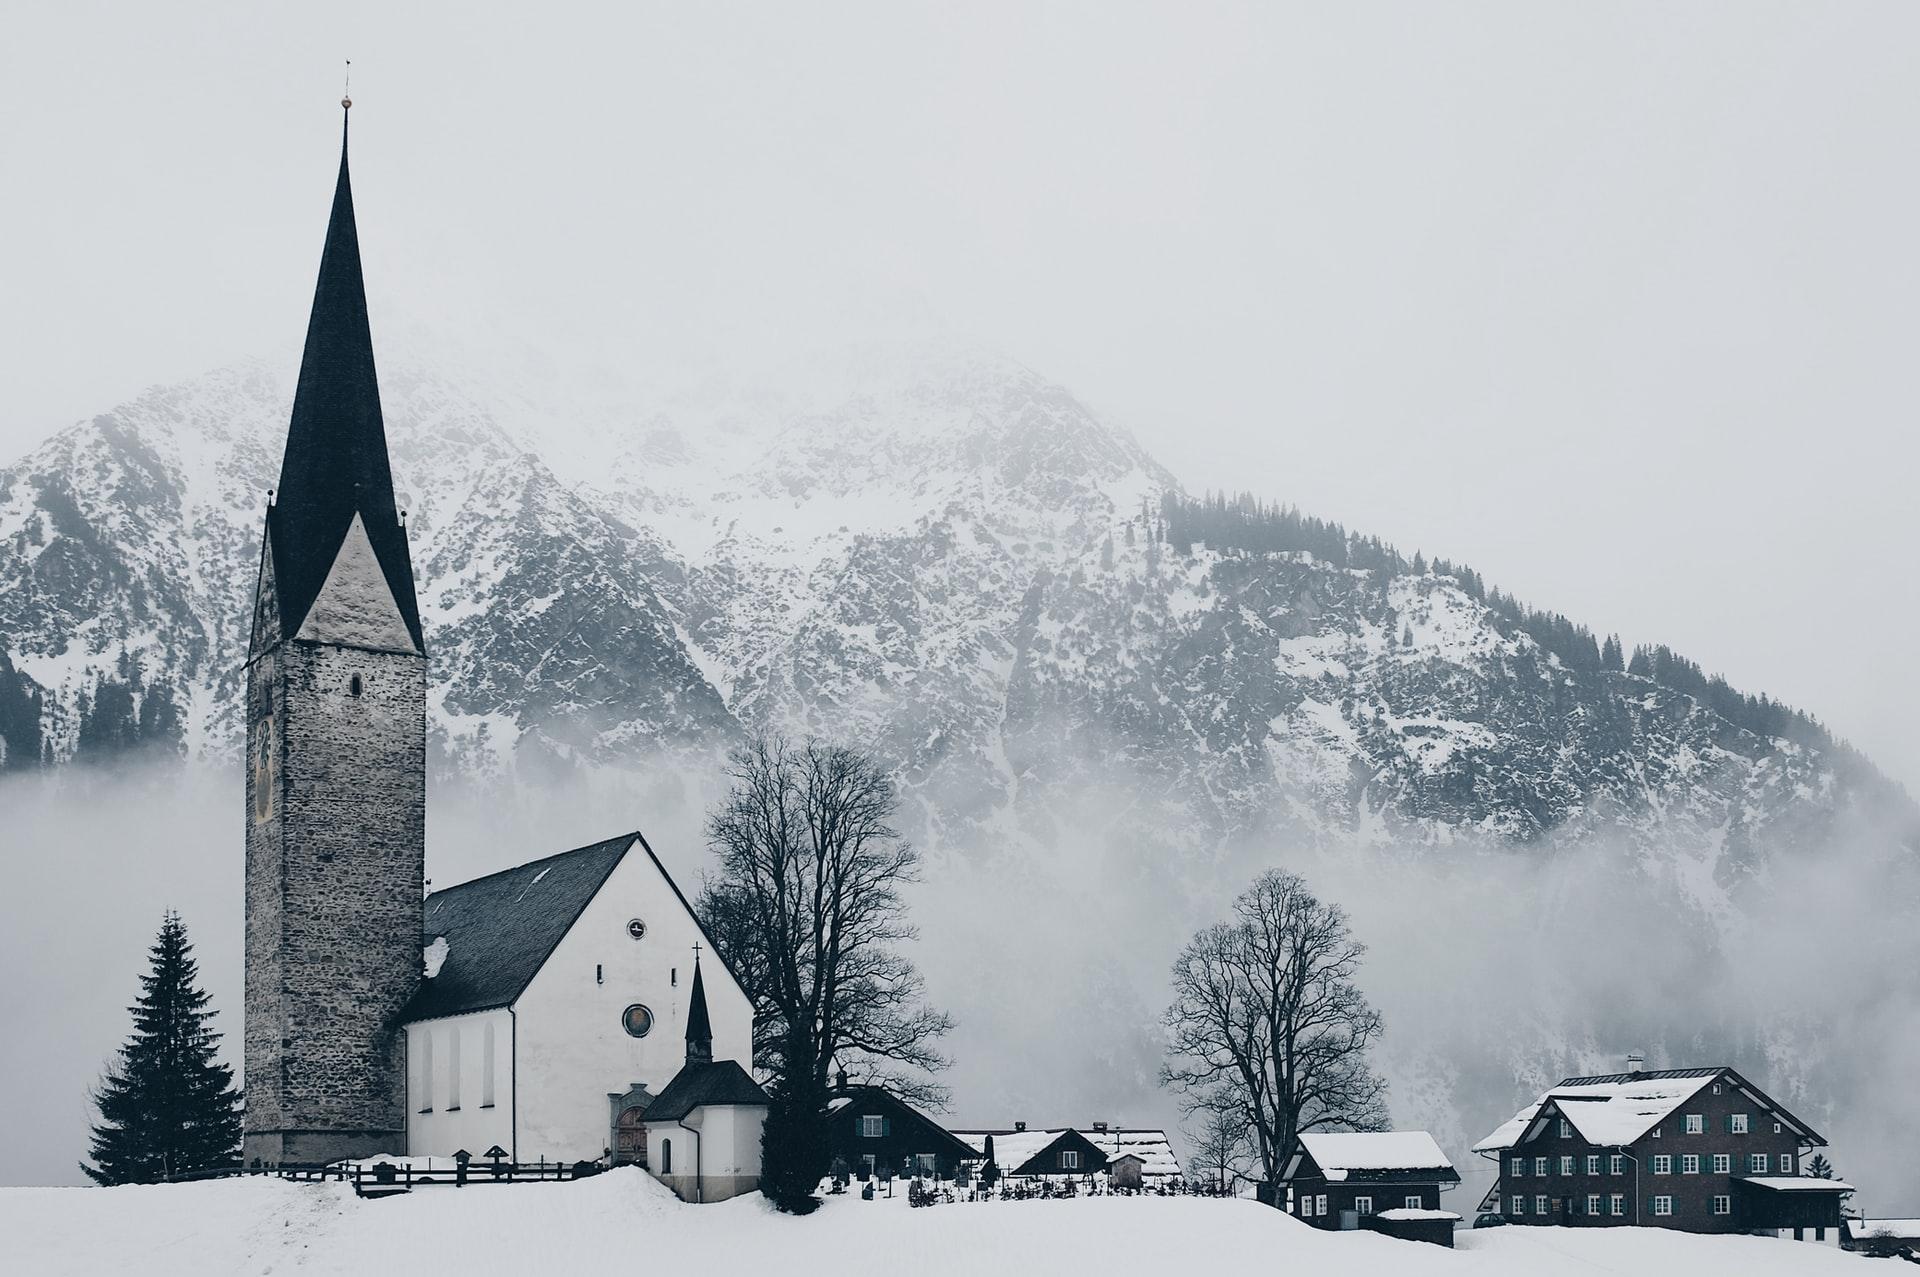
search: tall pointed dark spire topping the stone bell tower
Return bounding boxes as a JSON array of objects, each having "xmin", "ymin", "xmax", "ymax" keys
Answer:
[{"xmin": 267, "ymin": 98, "xmax": 424, "ymax": 651}]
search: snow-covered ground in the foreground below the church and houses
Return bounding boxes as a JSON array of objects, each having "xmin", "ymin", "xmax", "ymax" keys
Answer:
[{"xmin": 0, "ymin": 1171, "xmax": 1885, "ymax": 1277}]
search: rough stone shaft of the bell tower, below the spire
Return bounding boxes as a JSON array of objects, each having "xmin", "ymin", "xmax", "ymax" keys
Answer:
[{"xmin": 244, "ymin": 639, "xmax": 426, "ymax": 1162}]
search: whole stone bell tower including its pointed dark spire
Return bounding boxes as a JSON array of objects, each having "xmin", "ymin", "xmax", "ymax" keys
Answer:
[{"xmin": 244, "ymin": 100, "xmax": 426, "ymax": 1162}]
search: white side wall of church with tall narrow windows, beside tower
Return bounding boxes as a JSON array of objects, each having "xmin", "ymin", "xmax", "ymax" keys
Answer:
[{"xmin": 407, "ymin": 1008, "xmax": 513, "ymax": 1160}]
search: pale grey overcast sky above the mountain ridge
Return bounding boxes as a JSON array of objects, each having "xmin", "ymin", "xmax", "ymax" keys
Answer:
[{"xmin": 0, "ymin": 0, "xmax": 1920, "ymax": 789}]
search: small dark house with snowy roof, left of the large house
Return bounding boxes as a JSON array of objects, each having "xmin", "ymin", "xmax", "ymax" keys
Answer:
[{"xmin": 1281, "ymin": 1131, "xmax": 1459, "ymax": 1246}]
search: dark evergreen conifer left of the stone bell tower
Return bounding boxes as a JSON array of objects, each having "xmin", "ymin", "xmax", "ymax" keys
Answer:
[{"xmin": 81, "ymin": 912, "xmax": 240, "ymax": 1185}]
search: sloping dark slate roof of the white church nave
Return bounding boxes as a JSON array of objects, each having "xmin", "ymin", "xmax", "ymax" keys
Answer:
[{"xmin": 401, "ymin": 833, "xmax": 641, "ymax": 1022}]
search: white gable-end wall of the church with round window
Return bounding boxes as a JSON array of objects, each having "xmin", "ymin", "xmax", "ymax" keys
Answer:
[{"xmin": 515, "ymin": 845, "xmax": 753, "ymax": 1162}]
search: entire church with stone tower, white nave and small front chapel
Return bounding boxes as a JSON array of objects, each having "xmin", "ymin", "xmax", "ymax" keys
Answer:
[{"xmin": 244, "ymin": 100, "xmax": 766, "ymax": 1200}]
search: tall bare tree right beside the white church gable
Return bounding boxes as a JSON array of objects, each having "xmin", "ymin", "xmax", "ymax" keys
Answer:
[{"xmin": 699, "ymin": 737, "xmax": 952, "ymax": 1208}]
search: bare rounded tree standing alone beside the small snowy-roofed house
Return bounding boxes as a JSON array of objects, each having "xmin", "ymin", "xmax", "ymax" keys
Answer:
[{"xmin": 1162, "ymin": 870, "xmax": 1386, "ymax": 1183}]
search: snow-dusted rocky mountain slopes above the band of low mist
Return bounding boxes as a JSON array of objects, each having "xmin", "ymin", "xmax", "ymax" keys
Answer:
[{"xmin": 0, "ymin": 337, "xmax": 1897, "ymax": 856}]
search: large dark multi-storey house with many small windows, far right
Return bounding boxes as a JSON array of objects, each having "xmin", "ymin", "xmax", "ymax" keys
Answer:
[{"xmin": 1475, "ymin": 1066, "xmax": 1849, "ymax": 1241}]
